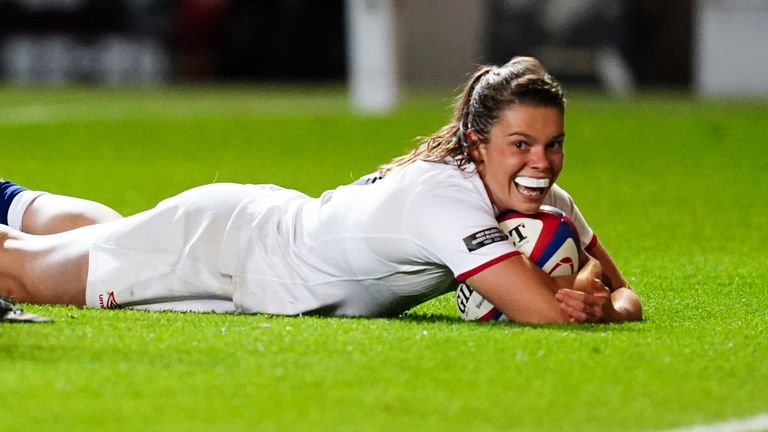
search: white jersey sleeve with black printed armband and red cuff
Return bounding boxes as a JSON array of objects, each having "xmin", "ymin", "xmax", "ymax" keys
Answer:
[{"xmin": 409, "ymin": 178, "xmax": 520, "ymax": 282}]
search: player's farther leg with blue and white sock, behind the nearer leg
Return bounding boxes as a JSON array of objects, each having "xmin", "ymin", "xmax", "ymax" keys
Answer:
[{"xmin": 0, "ymin": 181, "xmax": 122, "ymax": 234}]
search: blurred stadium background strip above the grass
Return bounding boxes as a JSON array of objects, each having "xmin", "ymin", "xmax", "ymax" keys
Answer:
[{"xmin": 0, "ymin": 0, "xmax": 768, "ymax": 109}]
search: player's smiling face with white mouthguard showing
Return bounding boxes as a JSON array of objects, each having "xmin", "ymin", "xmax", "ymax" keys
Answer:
[{"xmin": 467, "ymin": 104, "xmax": 565, "ymax": 213}]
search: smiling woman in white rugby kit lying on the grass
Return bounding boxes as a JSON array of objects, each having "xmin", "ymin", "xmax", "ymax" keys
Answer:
[{"xmin": 0, "ymin": 57, "xmax": 642, "ymax": 323}]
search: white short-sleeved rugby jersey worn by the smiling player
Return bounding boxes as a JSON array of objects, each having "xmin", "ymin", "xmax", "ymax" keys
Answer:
[{"xmin": 218, "ymin": 161, "xmax": 593, "ymax": 316}]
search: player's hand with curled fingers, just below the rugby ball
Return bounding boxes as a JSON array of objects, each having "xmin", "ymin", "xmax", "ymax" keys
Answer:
[{"xmin": 555, "ymin": 278, "xmax": 616, "ymax": 323}]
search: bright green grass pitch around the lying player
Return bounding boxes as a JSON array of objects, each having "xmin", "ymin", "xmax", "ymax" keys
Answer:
[{"xmin": 0, "ymin": 87, "xmax": 768, "ymax": 431}]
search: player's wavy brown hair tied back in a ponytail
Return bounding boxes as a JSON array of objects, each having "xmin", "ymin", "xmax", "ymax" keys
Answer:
[{"xmin": 379, "ymin": 57, "xmax": 565, "ymax": 176}]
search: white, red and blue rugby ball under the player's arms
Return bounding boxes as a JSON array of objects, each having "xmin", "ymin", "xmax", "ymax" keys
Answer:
[{"xmin": 456, "ymin": 206, "xmax": 579, "ymax": 321}]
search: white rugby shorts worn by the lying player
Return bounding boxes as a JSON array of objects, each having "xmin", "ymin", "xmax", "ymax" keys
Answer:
[{"xmin": 85, "ymin": 183, "xmax": 281, "ymax": 312}]
